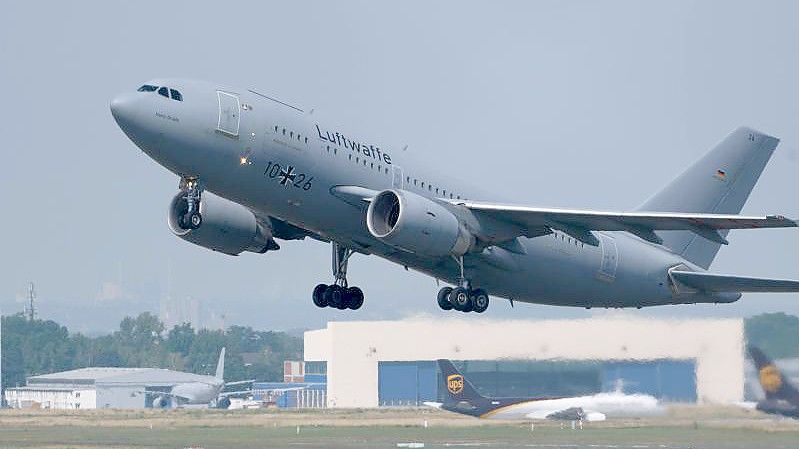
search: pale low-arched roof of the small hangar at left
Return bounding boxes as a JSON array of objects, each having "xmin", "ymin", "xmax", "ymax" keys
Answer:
[{"xmin": 28, "ymin": 368, "xmax": 213, "ymax": 386}]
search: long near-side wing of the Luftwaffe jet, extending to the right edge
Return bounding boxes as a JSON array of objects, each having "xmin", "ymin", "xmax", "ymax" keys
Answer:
[{"xmin": 456, "ymin": 200, "xmax": 799, "ymax": 246}]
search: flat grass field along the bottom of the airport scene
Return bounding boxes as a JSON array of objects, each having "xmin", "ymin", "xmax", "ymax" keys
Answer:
[{"xmin": 0, "ymin": 407, "xmax": 799, "ymax": 449}]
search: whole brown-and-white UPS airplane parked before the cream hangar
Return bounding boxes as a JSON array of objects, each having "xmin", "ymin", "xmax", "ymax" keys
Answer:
[{"xmin": 425, "ymin": 360, "xmax": 665, "ymax": 421}]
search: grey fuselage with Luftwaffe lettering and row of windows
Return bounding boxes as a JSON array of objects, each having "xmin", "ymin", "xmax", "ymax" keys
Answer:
[{"xmin": 112, "ymin": 80, "xmax": 740, "ymax": 307}]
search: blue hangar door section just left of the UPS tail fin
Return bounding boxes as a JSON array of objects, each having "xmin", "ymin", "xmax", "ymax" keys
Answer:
[{"xmin": 377, "ymin": 361, "xmax": 438, "ymax": 406}]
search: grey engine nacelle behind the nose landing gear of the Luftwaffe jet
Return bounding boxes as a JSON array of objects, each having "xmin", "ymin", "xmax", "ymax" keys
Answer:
[{"xmin": 168, "ymin": 191, "xmax": 275, "ymax": 256}]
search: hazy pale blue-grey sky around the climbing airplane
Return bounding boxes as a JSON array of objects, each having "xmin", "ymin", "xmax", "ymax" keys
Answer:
[{"xmin": 0, "ymin": 0, "xmax": 799, "ymax": 332}]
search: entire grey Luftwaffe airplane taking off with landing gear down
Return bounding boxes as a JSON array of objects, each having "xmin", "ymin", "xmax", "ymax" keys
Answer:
[{"xmin": 111, "ymin": 79, "xmax": 799, "ymax": 312}]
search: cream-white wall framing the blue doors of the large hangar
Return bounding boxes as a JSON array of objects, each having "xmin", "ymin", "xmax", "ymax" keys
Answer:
[{"xmin": 305, "ymin": 318, "xmax": 744, "ymax": 407}]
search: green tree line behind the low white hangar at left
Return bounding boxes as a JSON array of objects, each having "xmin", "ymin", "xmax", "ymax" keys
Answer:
[{"xmin": 2, "ymin": 312, "xmax": 302, "ymax": 388}]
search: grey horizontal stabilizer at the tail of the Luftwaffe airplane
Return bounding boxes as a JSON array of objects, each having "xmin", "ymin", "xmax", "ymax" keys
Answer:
[{"xmin": 670, "ymin": 271, "xmax": 799, "ymax": 293}]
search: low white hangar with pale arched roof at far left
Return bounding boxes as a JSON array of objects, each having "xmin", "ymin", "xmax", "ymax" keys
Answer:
[{"xmin": 5, "ymin": 368, "xmax": 212, "ymax": 409}]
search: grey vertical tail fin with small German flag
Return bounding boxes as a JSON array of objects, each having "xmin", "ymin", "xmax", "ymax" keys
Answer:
[{"xmin": 638, "ymin": 127, "xmax": 779, "ymax": 268}]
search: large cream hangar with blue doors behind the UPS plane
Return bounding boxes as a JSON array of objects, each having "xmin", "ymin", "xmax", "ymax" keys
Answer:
[{"xmin": 304, "ymin": 315, "xmax": 745, "ymax": 408}]
